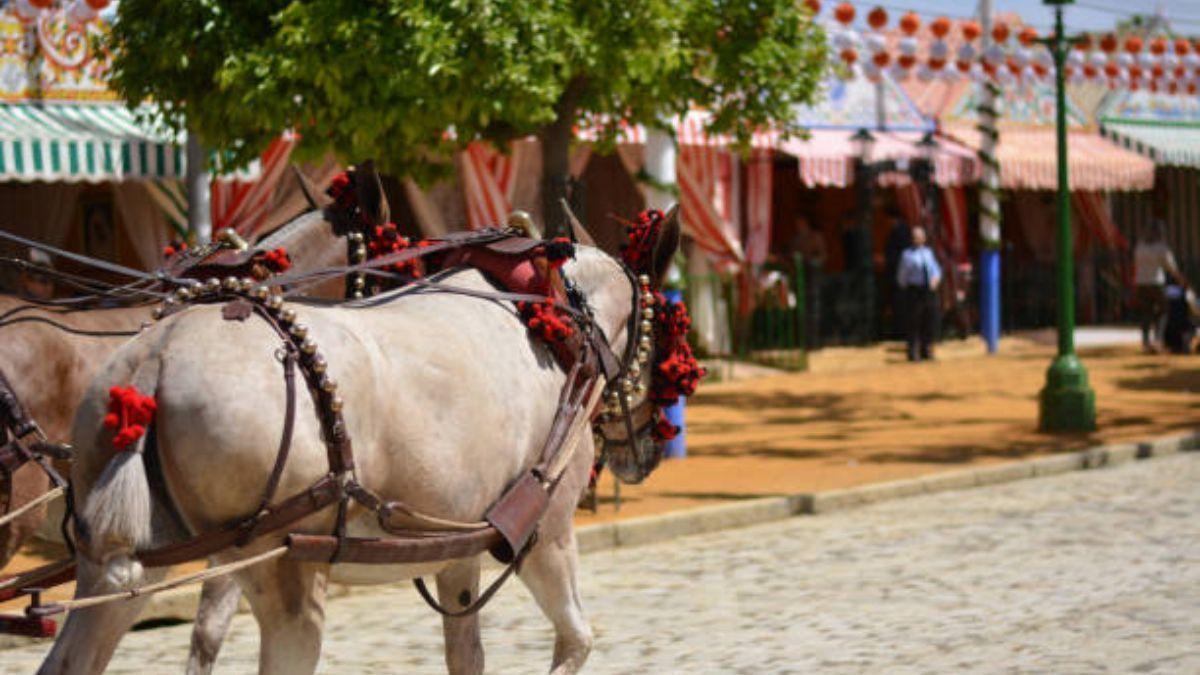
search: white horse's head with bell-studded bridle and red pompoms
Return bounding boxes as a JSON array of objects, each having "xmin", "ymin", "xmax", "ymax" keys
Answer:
[{"xmin": 566, "ymin": 210, "xmax": 691, "ymax": 483}]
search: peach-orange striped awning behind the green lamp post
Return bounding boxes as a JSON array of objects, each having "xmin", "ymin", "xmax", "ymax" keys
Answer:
[{"xmin": 946, "ymin": 126, "xmax": 1154, "ymax": 192}]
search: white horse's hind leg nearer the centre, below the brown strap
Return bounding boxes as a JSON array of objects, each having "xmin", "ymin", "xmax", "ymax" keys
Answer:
[{"xmin": 231, "ymin": 552, "xmax": 329, "ymax": 675}]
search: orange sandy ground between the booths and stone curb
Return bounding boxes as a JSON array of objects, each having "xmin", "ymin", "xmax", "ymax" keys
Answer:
[{"xmin": 0, "ymin": 334, "xmax": 1200, "ymax": 607}]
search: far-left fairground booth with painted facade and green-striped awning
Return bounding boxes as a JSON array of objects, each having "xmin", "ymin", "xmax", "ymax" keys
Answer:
[{"xmin": 0, "ymin": 2, "xmax": 322, "ymax": 288}]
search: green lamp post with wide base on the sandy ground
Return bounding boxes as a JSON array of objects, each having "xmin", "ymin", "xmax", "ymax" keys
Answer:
[{"xmin": 1038, "ymin": 0, "xmax": 1096, "ymax": 431}]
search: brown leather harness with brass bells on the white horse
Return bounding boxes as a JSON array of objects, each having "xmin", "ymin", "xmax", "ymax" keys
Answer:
[{"xmin": 35, "ymin": 229, "xmax": 641, "ymax": 616}]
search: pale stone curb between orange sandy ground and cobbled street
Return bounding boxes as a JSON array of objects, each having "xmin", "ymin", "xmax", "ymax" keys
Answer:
[{"xmin": 0, "ymin": 430, "xmax": 1200, "ymax": 650}]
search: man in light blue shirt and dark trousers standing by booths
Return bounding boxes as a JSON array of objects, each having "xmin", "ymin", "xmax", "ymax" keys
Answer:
[{"xmin": 896, "ymin": 227, "xmax": 942, "ymax": 362}]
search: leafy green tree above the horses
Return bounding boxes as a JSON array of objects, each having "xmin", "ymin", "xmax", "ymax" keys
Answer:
[{"xmin": 108, "ymin": 0, "xmax": 826, "ymax": 230}]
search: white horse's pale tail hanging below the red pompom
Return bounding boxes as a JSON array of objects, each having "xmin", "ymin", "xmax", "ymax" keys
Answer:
[{"xmin": 79, "ymin": 358, "xmax": 160, "ymax": 589}]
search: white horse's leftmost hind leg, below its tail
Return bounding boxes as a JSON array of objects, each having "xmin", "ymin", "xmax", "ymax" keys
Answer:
[{"xmin": 37, "ymin": 561, "xmax": 167, "ymax": 675}]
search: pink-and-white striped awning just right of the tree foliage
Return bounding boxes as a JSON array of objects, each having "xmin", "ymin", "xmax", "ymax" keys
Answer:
[{"xmin": 780, "ymin": 130, "xmax": 979, "ymax": 187}]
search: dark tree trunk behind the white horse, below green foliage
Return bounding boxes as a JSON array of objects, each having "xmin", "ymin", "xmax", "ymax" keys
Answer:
[{"xmin": 538, "ymin": 78, "xmax": 583, "ymax": 239}]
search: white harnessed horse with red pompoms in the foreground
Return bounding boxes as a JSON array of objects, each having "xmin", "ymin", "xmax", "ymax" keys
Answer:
[{"xmin": 41, "ymin": 196, "xmax": 678, "ymax": 674}]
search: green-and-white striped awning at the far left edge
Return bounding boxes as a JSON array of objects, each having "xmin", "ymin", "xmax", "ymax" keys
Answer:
[{"xmin": 0, "ymin": 102, "xmax": 184, "ymax": 183}]
